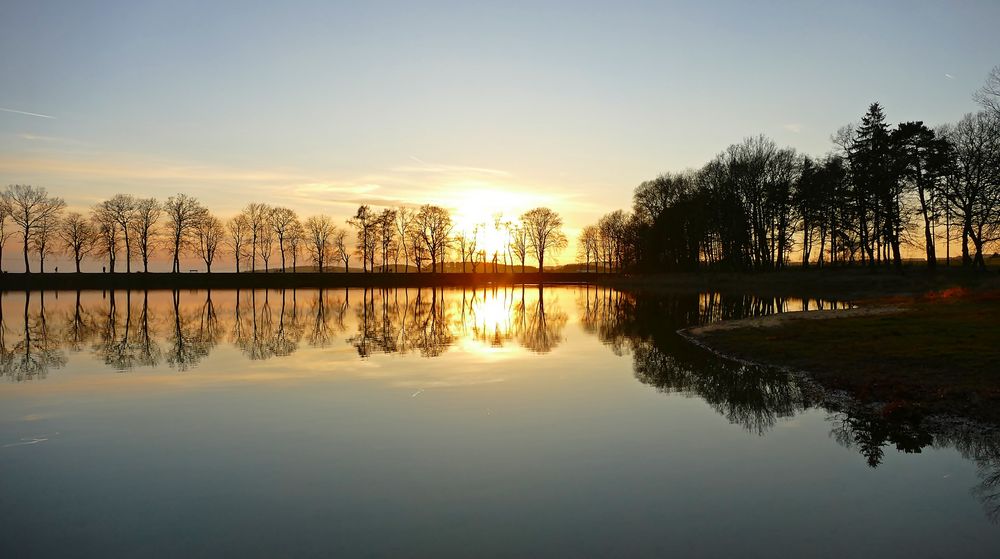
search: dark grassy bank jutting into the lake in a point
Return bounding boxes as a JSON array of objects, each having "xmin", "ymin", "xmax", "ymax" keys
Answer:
[{"xmin": 684, "ymin": 281, "xmax": 1000, "ymax": 422}]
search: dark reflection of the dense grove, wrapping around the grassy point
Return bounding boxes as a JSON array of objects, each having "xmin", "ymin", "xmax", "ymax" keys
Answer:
[{"xmin": 580, "ymin": 287, "xmax": 1000, "ymax": 522}]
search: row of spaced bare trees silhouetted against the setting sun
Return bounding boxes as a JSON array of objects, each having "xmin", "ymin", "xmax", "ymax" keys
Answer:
[{"xmin": 0, "ymin": 184, "xmax": 566, "ymax": 273}]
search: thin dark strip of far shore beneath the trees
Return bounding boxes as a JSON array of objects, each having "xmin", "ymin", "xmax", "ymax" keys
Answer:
[{"xmin": 0, "ymin": 267, "xmax": 1000, "ymax": 296}]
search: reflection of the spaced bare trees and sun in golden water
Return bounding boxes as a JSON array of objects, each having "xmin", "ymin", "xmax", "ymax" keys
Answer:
[{"xmin": 0, "ymin": 286, "xmax": 568, "ymax": 381}]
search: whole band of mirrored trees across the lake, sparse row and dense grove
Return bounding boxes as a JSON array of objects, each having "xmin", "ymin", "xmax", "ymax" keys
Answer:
[{"xmin": 0, "ymin": 286, "xmax": 1000, "ymax": 520}]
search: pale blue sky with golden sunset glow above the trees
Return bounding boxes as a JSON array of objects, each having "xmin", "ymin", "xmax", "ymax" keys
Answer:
[{"xmin": 0, "ymin": 0, "xmax": 1000, "ymax": 270}]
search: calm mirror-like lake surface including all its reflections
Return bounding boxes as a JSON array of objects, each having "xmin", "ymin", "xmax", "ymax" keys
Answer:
[{"xmin": 0, "ymin": 286, "xmax": 1000, "ymax": 558}]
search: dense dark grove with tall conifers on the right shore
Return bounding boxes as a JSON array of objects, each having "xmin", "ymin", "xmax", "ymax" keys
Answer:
[{"xmin": 578, "ymin": 66, "xmax": 1000, "ymax": 271}]
